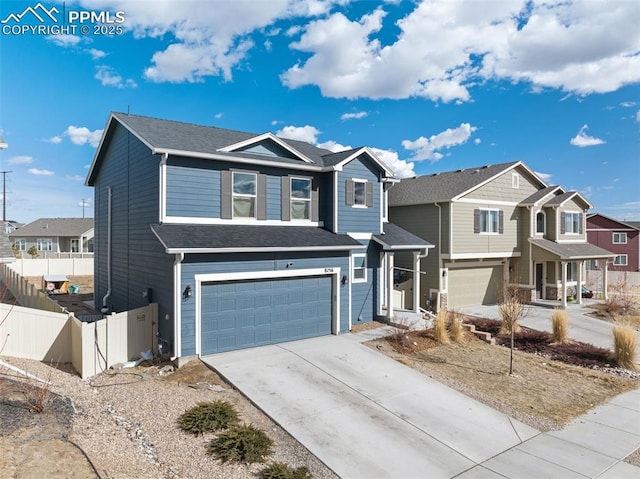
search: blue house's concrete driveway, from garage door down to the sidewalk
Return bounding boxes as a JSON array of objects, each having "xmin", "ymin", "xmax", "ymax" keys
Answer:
[{"xmin": 202, "ymin": 335, "xmax": 538, "ymax": 479}]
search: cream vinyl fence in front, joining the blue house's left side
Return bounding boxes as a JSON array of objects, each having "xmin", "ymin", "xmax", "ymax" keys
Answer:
[{"xmin": 0, "ymin": 304, "xmax": 158, "ymax": 379}]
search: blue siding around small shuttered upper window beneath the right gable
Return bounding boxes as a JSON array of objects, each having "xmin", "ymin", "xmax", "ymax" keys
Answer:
[{"xmin": 337, "ymin": 156, "xmax": 382, "ymax": 234}]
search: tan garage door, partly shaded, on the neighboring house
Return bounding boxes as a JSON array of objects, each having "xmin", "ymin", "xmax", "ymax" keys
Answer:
[{"xmin": 447, "ymin": 266, "xmax": 502, "ymax": 309}]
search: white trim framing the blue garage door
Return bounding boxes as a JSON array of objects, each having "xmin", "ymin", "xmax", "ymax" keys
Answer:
[{"xmin": 194, "ymin": 268, "xmax": 340, "ymax": 356}]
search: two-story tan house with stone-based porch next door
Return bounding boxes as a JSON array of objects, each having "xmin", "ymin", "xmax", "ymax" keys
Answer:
[{"xmin": 389, "ymin": 161, "xmax": 614, "ymax": 309}]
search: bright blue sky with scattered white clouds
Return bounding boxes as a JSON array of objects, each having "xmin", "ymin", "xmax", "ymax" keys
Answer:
[{"xmin": 0, "ymin": 0, "xmax": 640, "ymax": 222}]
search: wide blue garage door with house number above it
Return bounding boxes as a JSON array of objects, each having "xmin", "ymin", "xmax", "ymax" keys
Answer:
[{"xmin": 200, "ymin": 276, "xmax": 332, "ymax": 355}]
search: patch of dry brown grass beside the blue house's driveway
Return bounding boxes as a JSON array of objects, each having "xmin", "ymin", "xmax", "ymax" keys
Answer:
[{"xmin": 370, "ymin": 332, "xmax": 640, "ymax": 430}]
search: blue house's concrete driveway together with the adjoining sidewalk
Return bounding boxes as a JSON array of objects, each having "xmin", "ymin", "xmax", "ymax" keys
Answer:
[{"xmin": 202, "ymin": 334, "xmax": 640, "ymax": 479}]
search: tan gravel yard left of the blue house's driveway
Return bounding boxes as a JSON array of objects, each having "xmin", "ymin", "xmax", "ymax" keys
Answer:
[{"xmin": 0, "ymin": 357, "xmax": 337, "ymax": 479}]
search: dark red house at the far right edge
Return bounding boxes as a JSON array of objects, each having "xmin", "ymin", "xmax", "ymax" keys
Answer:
[{"xmin": 587, "ymin": 213, "xmax": 640, "ymax": 271}]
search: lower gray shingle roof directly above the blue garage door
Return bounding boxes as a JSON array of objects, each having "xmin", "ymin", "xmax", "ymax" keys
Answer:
[{"xmin": 151, "ymin": 224, "xmax": 362, "ymax": 253}]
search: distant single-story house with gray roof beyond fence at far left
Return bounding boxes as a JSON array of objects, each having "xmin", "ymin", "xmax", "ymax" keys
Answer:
[{"xmin": 9, "ymin": 218, "xmax": 93, "ymax": 258}]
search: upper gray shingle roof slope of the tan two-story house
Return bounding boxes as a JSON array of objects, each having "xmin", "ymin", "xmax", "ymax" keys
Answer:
[{"xmin": 389, "ymin": 161, "xmax": 520, "ymax": 206}]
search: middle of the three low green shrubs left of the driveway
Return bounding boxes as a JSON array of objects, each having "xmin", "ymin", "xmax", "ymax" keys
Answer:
[{"xmin": 207, "ymin": 424, "xmax": 273, "ymax": 464}]
